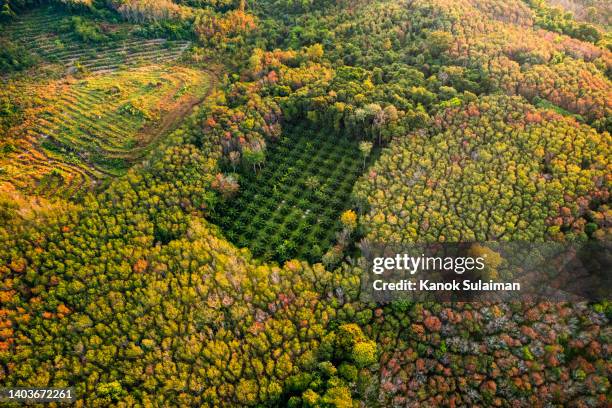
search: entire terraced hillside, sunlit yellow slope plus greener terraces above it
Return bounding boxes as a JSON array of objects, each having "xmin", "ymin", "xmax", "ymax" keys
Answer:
[{"xmin": 0, "ymin": 8, "xmax": 210, "ymax": 196}]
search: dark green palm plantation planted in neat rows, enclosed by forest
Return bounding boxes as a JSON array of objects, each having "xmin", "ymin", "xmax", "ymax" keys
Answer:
[{"xmin": 213, "ymin": 129, "xmax": 372, "ymax": 262}]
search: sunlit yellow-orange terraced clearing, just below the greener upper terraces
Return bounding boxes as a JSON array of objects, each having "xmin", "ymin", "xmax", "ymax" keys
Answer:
[{"xmin": 0, "ymin": 65, "xmax": 210, "ymax": 194}]
